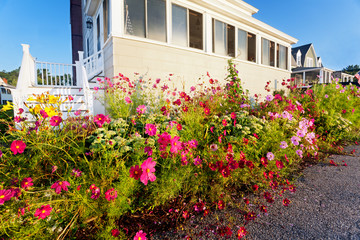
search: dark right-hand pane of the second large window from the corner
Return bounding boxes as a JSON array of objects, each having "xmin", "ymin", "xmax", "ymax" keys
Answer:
[{"xmin": 189, "ymin": 10, "xmax": 203, "ymax": 49}]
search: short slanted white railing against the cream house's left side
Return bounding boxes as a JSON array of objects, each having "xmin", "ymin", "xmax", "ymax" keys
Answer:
[{"xmin": 79, "ymin": 50, "xmax": 104, "ymax": 79}]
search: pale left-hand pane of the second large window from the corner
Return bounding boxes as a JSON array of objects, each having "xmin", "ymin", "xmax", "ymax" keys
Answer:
[{"xmin": 172, "ymin": 4, "xmax": 188, "ymax": 47}]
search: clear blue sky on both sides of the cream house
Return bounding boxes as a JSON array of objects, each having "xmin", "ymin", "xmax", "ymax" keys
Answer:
[{"xmin": 0, "ymin": 0, "xmax": 360, "ymax": 71}]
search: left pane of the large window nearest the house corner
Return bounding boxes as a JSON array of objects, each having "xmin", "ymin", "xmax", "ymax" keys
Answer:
[{"xmin": 124, "ymin": 0, "xmax": 145, "ymax": 37}]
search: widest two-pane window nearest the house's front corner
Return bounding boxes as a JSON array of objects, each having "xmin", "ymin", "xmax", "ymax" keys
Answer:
[{"xmin": 124, "ymin": 0, "xmax": 166, "ymax": 42}]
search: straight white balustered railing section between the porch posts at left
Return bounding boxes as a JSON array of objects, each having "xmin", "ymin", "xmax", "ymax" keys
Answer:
[{"xmin": 35, "ymin": 61, "xmax": 76, "ymax": 87}]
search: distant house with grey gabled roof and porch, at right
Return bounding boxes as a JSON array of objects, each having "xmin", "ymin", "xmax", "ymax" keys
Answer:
[{"xmin": 291, "ymin": 43, "xmax": 353, "ymax": 85}]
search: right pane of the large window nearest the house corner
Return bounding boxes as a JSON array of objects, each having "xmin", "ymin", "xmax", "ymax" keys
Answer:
[{"xmin": 147, "ymin": 0, "xmax": 166, "ymax": 42}]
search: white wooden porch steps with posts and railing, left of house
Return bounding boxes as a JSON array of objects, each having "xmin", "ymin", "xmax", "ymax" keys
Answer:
[{"xmin": 12, "ymin": 44, "xmax": 103, "ymax": 121}]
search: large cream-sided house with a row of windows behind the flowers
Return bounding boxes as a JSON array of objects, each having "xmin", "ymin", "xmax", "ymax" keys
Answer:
[{"xmin": 71, "ymin": 0, "xmax": 297, "ymax": 94}]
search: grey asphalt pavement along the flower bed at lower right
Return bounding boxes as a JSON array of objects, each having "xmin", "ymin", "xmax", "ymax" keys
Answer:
[{"xmin": 153, "ymin": 146, "xmax": 360, "ymax": 240}]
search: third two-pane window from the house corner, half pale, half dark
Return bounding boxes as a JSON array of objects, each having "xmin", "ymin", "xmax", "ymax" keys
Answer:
[{"xmin": 213, "ymin": 19, "xmax": 235, "ymax": 57}]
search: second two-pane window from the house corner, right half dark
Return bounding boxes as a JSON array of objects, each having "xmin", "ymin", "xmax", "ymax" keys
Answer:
[{"xmin": 172, "ymin": 4, "xmax": 203, "ymax": 49}]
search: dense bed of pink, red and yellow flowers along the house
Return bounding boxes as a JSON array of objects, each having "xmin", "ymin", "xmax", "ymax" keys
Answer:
[{"xmin": 0, "ymin": 63, "xmax": 360, "ymax": 239}]
